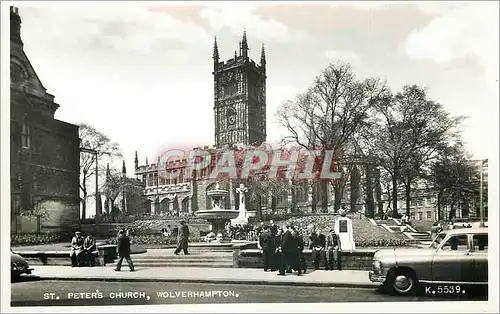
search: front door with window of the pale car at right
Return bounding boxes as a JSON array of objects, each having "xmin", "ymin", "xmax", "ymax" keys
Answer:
[{"xmin": 432, "ymin": 234, "xmax": 474, "ymax": 283}]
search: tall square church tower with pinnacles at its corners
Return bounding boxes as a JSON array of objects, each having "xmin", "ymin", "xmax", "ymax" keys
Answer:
[{"xmin": 213, "ymin": 31, "xmax": 266, "ymax": 147}]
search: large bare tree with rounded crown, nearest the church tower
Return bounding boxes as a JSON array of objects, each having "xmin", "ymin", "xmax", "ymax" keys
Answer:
[{"xmin": 277, "ymin": 63, "xmax": 387, "ymax": 210}]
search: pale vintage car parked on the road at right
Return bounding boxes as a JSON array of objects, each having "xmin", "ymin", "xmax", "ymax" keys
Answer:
[{"xmin": 369, "ymin": 228, "xmax": 488, "ymax": 295}]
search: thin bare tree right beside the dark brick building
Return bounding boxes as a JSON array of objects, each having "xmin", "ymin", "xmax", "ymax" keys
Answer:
[{"xmin": 79, "ymin": 123, "xmax": 122, "ymax": 219}]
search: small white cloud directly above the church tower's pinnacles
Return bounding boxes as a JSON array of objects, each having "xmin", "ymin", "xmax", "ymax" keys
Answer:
[{"xmin": 200, "ymin": 2, "xmax": 303, "ymax": 42}]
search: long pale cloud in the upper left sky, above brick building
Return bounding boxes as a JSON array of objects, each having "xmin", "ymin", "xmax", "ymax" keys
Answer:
[{"xmin": 20, "ymin": 3, "xmax": 212, "ymax": 53}]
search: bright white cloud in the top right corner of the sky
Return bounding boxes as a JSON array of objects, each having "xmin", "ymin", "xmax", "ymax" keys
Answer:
[{"xmin": 404, "ymin": 2, "xmax": 499, "ymax": 82}]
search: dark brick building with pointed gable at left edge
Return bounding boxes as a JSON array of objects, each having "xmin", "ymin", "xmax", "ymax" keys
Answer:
[{"xmin": 10, "ymin": 7, "xmax": 80, "ymax": 233}]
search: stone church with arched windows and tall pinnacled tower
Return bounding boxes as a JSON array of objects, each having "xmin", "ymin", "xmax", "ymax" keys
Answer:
[{"xmin": 135, "ymin": 32, "xmax": 376, "ymax": 215}]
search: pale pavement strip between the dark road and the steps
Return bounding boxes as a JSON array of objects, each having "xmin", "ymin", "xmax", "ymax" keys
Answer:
[{"xmin": 28, "ymin": 261, "xmax": 379, "ymax": 288}]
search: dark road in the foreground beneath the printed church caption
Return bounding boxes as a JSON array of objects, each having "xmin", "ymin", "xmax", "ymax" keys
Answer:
[{"xmin": 11, "ymin": 277, "xmax": 486, "ymax": 306}]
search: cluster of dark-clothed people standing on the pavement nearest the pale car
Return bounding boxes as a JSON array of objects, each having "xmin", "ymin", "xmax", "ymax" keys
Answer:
[{"xmin": 259, "ymin": 224, "xmax": 342, "ymax": 276}]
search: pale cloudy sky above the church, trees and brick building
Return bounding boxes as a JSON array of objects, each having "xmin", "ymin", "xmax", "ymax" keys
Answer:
[{"xmin": 2, "ymin": 1, "xmax": 499, "ymax": 213}]
